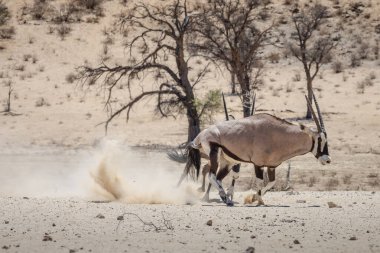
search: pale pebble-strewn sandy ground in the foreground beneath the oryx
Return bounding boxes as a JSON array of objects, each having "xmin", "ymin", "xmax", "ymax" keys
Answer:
[{"xmin": 0, "ymin": 192, "xmax": 380, "ymax": 252}]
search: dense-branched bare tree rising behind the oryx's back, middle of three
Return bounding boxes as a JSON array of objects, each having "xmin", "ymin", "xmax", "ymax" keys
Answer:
[{"xmin": 192, "ymin": 0, "xmax": 273, "ymax": 117}]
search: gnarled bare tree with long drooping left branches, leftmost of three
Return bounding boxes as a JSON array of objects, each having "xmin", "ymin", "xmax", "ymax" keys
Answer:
[{"xmin": 80, "ymin": 0, "xmax": 214, "ymax": 141}]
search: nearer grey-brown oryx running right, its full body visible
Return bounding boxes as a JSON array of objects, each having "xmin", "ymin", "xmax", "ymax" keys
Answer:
[{"xmin": 185, "ymin": 94, "xmax": 331, "ymax": 206}]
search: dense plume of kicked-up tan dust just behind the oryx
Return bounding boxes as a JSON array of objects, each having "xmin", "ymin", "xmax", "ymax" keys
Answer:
[{"xmin": 89, "ymin": 142, "xmax": 200, "ymax": 204}]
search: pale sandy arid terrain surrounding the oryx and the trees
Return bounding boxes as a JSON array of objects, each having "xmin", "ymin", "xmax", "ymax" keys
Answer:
[{"xmin": 0, "ymin": 0, "xmax": 380, "ymax": 252}]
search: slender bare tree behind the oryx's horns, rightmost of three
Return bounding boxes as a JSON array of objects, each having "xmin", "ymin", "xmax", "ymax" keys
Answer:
[{"xmin": 289, "ymin": 4, "xmax": 339, "ymax": 119}]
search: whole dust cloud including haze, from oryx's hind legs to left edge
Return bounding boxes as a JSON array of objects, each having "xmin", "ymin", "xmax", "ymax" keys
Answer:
[{"xmin": 0, "ymin": 140, "xmax": 201, "ymax": 204}]
